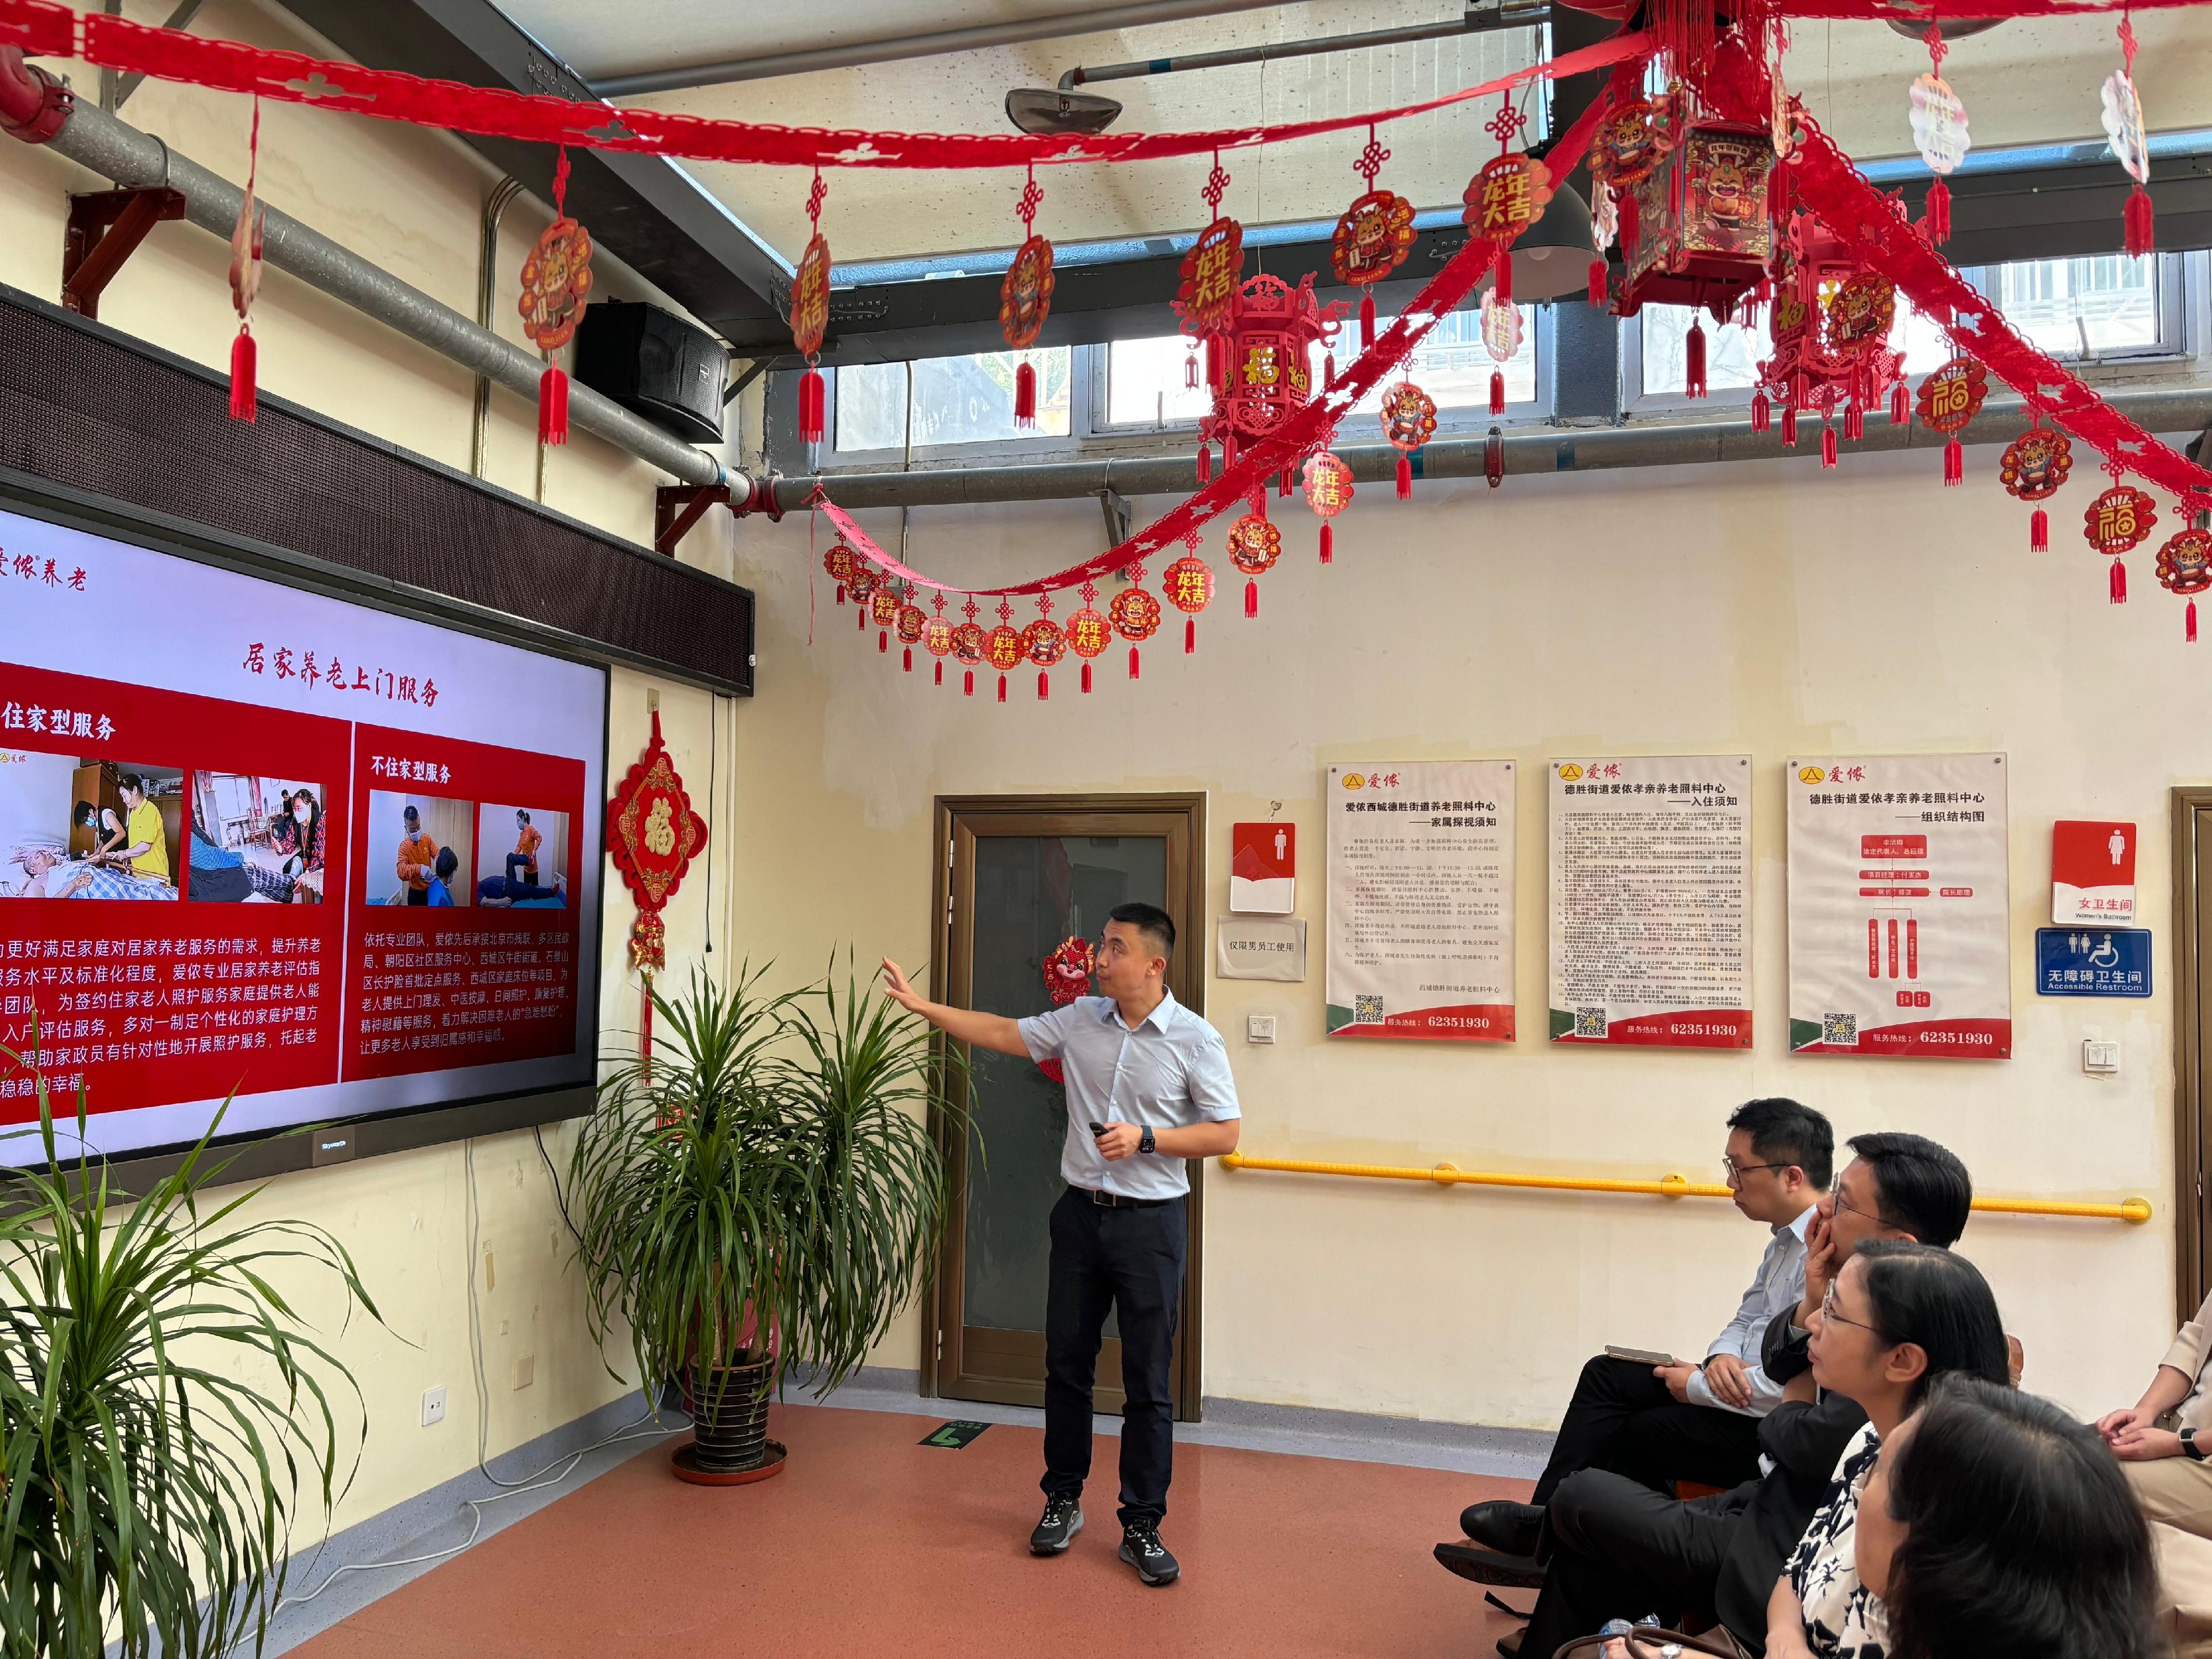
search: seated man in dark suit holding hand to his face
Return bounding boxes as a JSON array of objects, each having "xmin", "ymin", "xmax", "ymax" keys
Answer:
[{"xmin": 1491, "ymin": 1135, "xmax": 1982, "ymax": 1657}]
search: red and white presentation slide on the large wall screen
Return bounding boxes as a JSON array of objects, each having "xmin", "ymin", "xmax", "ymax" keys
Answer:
[{"xmin": 0, "ymin": 511, "xmax": 606, "ymax": 1164}]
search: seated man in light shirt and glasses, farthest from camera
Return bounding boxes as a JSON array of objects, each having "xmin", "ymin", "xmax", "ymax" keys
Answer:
[{"xmin": 1436, "ymin": 1099, "xmax": 1836, "ymax": 1584}]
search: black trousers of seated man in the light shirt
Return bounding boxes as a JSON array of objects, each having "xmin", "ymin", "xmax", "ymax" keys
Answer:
[{"xmin": 1531, "ymin": 1354, "xmax": 1759, "ymax": 1513}]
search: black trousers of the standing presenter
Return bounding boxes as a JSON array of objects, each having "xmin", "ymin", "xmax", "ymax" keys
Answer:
[{"xmin": 1042, "ymin": 1188, "xmax": 1186, "ymax": 1526}]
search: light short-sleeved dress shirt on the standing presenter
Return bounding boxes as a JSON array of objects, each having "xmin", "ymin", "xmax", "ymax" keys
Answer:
[{"xmin": 1020, "ymin": 991, "xmax": 1243, "ymax": 1199}]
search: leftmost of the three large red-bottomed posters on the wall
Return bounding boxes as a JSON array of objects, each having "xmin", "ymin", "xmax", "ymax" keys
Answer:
[{"xmin": 1323, "ymin": 761, "xmax": 1513, "ymax": 1042}]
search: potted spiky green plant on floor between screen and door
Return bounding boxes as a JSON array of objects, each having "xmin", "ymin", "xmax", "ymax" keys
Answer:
[{"xmin": 571, "ymin": 964, "xmax": 951, "ymax": 1484}]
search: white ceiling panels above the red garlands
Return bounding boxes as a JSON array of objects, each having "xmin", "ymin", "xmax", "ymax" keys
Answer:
[{"xmin": 500, "ymin": 0, "xmax": 2212, "ymax": 261}]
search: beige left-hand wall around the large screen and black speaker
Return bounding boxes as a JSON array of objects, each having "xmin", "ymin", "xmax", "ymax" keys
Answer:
[{"xmin": 0, "ymin": 0, "xmax": 734, "ymax": 1544}]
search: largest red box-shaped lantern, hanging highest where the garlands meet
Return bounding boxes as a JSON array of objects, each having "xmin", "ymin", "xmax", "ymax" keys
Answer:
[{"xmin": 1615, "ymin": 122, "xmax": 1774, "ymax": 323}]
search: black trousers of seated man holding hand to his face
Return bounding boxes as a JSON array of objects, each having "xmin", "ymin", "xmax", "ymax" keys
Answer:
[{"xmin": 1522, "ymin": 1469, "xmax": 1765, "ymax": 1657}]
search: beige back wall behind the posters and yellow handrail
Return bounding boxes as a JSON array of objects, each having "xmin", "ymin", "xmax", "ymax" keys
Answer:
[{"xmin": 739, "ymin": 449, "xmax": 2177, "ymax": 1425}]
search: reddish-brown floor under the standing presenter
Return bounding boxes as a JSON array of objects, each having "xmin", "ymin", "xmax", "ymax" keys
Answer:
[{"xmin": 294, "ymin": 1405, "xmax": 1528, "ymax": 1659}]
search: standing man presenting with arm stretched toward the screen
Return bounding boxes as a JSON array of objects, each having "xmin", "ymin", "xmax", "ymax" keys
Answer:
[{"xmin": 883, "ymin": 902, "xmax": 1239, "ymax": 1586}]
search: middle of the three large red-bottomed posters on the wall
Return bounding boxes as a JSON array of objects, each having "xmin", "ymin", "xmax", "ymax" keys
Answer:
[{"xmin": 1551, "ymin": 754, "xmax": 1752, "ymax": 1048}]
